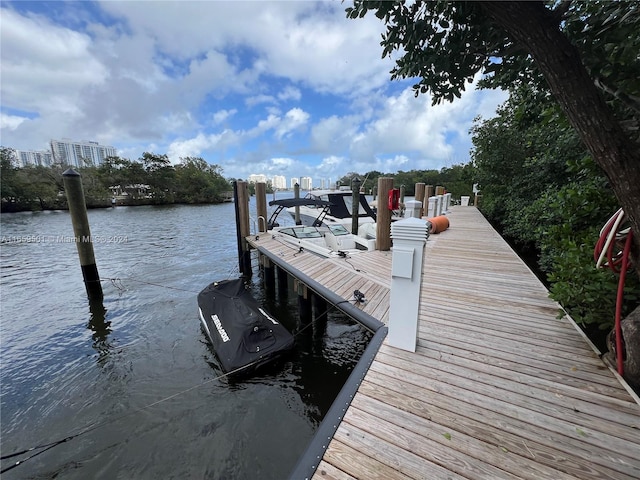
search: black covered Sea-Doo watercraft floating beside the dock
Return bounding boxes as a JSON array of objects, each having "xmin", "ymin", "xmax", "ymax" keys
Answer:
[{"xmin": 198, "ymin": 278, "xmax": 294, "ymax": 373}]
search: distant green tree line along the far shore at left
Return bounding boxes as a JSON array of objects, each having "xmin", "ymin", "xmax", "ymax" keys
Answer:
[{"xmin": 0, "ymin": 147, "xmax": 233, "ymax": 212}]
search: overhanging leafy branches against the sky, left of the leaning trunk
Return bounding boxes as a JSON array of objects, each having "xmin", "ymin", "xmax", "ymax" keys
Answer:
[{"xmin": 346, "ymin": 0, "xmax": 510, "ymax": 104}]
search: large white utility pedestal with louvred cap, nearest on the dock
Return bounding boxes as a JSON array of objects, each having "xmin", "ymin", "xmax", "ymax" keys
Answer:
[{"xmin": 387, "ymin": 218, "xmax": 429, "ymax": 352}]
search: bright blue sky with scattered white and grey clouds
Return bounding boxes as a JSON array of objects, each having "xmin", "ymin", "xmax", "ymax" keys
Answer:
[{"xmin": 0, "ymin": 0, "xmax": 507, "ymax": 186}]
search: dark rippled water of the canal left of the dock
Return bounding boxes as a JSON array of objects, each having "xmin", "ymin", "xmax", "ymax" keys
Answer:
[{"xmin": 0, "ymin": 200, "xmax": 370, "ymax": 479}]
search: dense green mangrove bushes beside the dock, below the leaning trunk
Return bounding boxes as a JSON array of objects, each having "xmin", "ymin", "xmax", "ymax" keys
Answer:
[{"xmin": 472, "ymin": 86, "xmax": 640, "ymax": 329}]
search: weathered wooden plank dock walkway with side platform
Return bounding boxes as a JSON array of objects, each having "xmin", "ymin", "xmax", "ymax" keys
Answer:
[{"xmin": 246, "ymin": 207, "xmax": 640, "ymax": 480}]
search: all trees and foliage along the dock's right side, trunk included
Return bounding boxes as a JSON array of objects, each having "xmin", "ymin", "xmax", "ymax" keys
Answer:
[{"xmin": 346, "ymin": 0, "xmax": 640, "ymax": 387}]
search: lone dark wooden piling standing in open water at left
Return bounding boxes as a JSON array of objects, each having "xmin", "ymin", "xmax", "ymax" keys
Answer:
[{"xmin": 62, "ymin": 168, "xmax": 103, "ymax": 300}]
